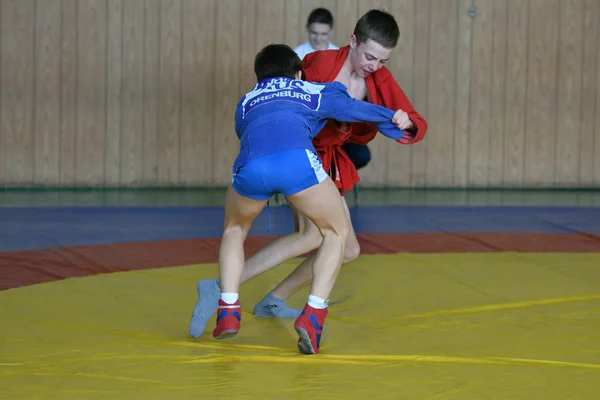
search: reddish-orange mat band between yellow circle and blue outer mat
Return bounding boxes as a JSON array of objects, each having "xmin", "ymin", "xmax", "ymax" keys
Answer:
[{"xmin": 0, "ymin": 233, "xmax": 600, "ymax": 290}]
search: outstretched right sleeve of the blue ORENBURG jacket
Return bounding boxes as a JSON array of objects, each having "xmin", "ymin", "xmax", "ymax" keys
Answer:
[{"xmin": 319, "ymin": 82, "xmax": 405, "ymax": 141}]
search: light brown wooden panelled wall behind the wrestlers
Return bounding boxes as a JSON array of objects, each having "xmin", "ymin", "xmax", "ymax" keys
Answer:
[{"xmin": 0, "ymin": 0, "xmax": 600, "ymax": 187}]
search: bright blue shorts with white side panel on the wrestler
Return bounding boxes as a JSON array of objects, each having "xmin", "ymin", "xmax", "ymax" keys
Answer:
[{"xmin": 232, "ymin": 149, "xmax": 327, "ymax": 200}]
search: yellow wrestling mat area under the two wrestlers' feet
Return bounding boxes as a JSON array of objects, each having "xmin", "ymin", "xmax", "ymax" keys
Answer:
[{"xmin": 0, "ymin": 253, "xmax": 600, "ymax": 400}]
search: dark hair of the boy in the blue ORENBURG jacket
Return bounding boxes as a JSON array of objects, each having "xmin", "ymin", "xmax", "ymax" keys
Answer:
[{"xmin": 254, "ymin": 44, "xmax": 302, "ymax": 81}]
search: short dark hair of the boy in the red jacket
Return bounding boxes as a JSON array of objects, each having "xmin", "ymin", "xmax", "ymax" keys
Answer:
[{"xmin": 354, "ymin": 10, "xmax": 400, "ymax": 49}]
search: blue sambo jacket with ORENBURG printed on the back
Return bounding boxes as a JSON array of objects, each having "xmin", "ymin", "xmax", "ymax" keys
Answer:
[{"xmin": 233, "ymin": 77, "xmax": 404, "ymax": 173}]
